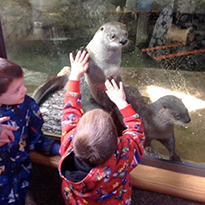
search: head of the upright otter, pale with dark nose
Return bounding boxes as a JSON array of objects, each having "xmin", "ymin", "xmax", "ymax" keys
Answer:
[{"xmin": 97, "ymin": 21, "xmax": 128, "ymax": 48}]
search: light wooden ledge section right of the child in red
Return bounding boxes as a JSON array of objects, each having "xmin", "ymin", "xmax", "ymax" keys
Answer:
[{"xmin": 131, "ymin": 164, "xmax": 205, "ymax": 203}]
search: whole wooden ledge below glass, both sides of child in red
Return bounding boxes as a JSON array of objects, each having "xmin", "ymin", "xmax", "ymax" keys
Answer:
[{"xmin": 30, "ymin": 152, "xmax": 205, "ymax": 203}]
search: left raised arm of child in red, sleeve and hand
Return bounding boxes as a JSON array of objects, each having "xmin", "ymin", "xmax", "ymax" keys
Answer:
[{"xmin": 60, "ymin": 50, "xmax": 89, "ymax": 155}]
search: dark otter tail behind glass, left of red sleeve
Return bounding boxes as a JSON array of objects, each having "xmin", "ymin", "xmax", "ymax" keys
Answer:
[{"xmin": 32, "ymin": 74, "xmax": 69, "ymax": 106}]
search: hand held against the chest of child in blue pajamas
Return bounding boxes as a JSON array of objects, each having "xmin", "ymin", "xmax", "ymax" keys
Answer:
[{"xmin": 0, "ymin": 117, "xmax": 18, "ymax": 147}]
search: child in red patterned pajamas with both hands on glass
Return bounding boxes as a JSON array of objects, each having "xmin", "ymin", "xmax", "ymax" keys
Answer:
[{"xmin": 59, "ymin": 48, "xmax": 145, "ymax": 205}]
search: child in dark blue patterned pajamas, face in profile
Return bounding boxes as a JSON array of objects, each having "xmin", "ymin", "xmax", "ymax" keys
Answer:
[{"xmin": 0, "ymin": 58, "xmax": 59, "ymax": 205}]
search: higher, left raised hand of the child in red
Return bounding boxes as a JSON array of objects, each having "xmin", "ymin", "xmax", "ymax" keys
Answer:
[{"xmin": 69, "ymin": 49, "xmax": 89, "ymax": 80}]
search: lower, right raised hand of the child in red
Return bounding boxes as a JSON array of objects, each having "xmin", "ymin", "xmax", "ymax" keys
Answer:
[{"xmin": 105, "ymin": 79, "xmax": 128, "ymax": 109}]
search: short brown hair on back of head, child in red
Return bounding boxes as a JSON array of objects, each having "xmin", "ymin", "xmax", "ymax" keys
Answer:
[{"xmin": 73, "ymin": 109, "xmax": 118, "ymax": 165}]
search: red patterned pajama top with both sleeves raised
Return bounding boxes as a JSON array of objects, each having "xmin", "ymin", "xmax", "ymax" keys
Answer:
[{"xmin": 59, "ymin": 81, "xmax": 145, "ymax": 205}]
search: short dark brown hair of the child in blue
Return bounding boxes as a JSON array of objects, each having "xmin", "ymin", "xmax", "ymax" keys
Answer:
[{"xmin": 0, "ymin": 58, "xmax": 23, "ymax": 95}]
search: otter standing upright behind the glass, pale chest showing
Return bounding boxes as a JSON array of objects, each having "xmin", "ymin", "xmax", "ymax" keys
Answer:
[{"xmin": 83, "ymin": 22, "xmax": 128, "ymax": 111}]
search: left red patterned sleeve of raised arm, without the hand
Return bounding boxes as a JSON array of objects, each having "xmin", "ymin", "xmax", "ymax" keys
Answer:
[{"xmin": 60, "ymin": 80, "xmax": 83, "ymax": 155}]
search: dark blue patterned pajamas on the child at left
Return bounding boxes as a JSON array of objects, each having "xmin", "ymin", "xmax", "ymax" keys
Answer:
[{"xmin": 0, "ymin": 95, "xmax": 43, "ymax": 205}]
